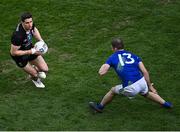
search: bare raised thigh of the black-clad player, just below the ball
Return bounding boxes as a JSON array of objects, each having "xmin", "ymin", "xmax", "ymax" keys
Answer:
[{"xmin": 30, "ymin": 55, "xmax": 48, "ymax": 72}]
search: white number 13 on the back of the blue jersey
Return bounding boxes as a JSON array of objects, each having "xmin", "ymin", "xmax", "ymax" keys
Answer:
[{"xmin": 118, "ymin": 53, "xmax": 135, "ymax": 66}]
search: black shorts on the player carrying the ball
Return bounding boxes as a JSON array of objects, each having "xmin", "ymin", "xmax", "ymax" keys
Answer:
[{"xmin": 11, "ymin": 55, "xmax": 38, "ymax": 68}]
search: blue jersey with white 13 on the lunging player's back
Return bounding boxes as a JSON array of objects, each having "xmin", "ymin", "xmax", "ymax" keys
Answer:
[{"xmin": 107, "ymin": 50, "xmax": 142, "ymax": 87}]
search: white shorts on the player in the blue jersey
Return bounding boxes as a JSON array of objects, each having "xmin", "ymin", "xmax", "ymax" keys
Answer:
[{"xmin": 114, "ymin": 77, "xmax": 148, "ymax": 97}]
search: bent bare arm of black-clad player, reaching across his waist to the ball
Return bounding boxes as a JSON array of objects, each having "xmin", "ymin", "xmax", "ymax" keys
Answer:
[{"xmin": 10, "ymin": 44, "xmax": 34, "ymax": 56}]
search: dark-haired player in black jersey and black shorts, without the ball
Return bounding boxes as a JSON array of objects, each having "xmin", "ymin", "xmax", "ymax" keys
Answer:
[{"xmin": 10, "ymin": 13, "xmax": 48, "ymax": 88}]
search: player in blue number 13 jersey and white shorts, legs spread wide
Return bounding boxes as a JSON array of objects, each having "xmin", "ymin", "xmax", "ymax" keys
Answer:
[{"xmin": 89, "ymin": 39, "xmax": 172, "ymax": 112}]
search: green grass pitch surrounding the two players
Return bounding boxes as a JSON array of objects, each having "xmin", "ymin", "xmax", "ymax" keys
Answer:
[{"xmin": 0, "ymin": 0, "xmax": 180, "ymax": 131}]
